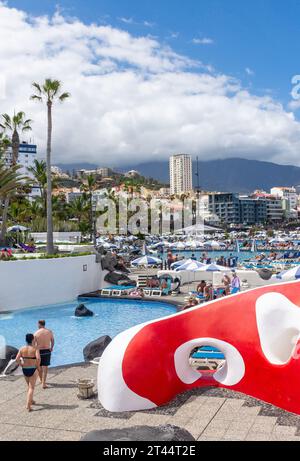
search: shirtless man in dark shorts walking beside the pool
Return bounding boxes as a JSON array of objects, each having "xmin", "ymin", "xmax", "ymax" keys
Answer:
[{"xmin": 34, "ymin": 320, "xmax": 54, "ymax": 389}]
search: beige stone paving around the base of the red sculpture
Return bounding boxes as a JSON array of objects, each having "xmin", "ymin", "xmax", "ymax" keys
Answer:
[{"xmin": 0, "ymin": 365, "xmax": 300, "ymax": 441}]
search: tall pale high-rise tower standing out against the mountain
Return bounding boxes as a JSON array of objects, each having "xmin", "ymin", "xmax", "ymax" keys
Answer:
[{"xmin": 170, "ymin": 154, "xmax": 193, "ymax": 195}]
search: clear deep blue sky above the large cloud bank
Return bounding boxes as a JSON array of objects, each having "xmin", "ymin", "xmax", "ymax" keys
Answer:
[{"xmin": 8, "ymin": 0, "xmax": 300, "ymax": 104}]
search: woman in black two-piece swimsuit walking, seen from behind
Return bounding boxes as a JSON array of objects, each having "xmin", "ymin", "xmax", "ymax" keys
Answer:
[{"xmin": 16, "ymin": 333, "xmax": 41, "ymax": 411}]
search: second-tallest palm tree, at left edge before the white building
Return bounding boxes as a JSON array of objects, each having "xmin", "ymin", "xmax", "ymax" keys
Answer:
[{"xmin": 0, "ymin": 112, "xmax": 32, "ymax": 243}]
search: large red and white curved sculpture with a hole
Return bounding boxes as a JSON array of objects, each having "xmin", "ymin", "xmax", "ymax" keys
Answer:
[{"xmin": 98, "ymin": 282, "xmax": 300, "ymax": 414}]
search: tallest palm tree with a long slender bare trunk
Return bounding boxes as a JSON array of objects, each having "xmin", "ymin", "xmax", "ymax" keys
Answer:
[{"xmin": 31, "ymin": 78, "xmax": 70, "ymax": 254}]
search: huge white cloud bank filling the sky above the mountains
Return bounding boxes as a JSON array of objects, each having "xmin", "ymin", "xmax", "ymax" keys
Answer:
[{"xmin": 0, "ymin": 4, "xmax": 300, "ymax": 166}]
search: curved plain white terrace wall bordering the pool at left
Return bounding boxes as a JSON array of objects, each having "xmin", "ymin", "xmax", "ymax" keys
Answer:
[{"xmin": 0, "ymin": 255, "xmax": 102, "ymax": 312}]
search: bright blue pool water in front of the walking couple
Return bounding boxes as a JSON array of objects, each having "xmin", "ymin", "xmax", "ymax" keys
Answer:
[{"xmin": 0, "ymin": 299, "xmax": 176, "ymax": 366}]
